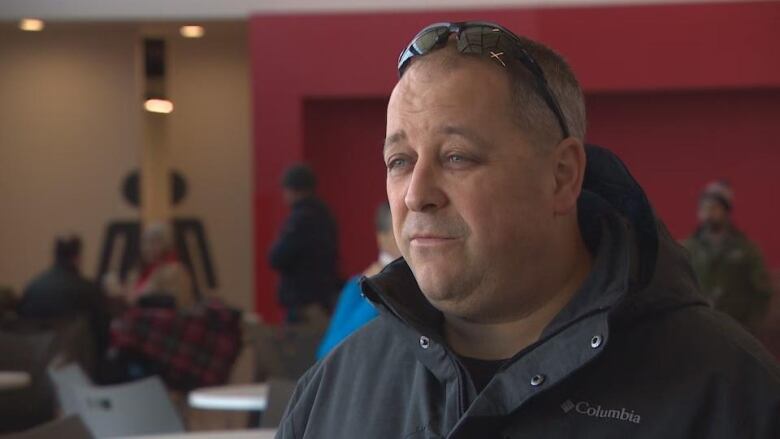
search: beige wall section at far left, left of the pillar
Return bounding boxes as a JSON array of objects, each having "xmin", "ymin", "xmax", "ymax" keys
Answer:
[{"xmin": 0, "ymin": 25, "xmax": 141, "ymax": 291}]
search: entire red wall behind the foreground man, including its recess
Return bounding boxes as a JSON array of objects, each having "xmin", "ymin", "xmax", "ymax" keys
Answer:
[{"xmin": 250, "ymin": 2, "xmax": 780, "ymax": 321}]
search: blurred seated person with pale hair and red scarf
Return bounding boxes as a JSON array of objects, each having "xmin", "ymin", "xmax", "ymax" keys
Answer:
[{"xmin": 104, "ymin": 222, "xmax": 195, "ymax": 309}]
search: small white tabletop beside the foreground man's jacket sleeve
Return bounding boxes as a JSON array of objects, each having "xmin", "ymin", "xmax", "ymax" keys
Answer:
[{"xmin": 188, "ymin": 383, "xmax": 268, "ymax": 411}]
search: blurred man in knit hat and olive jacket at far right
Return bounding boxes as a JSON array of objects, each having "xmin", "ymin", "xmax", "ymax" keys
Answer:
[{"xmin": 684, "ymin": 181, "xmax": 772, "ymax": 334}]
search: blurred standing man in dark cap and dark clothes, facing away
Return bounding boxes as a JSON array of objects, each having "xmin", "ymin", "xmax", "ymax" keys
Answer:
[{"xmin": 268, "ymin": 165, "xmax": 340, "ymax": 323}]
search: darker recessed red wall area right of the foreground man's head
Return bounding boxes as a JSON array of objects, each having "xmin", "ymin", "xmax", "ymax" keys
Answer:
[{"xmin": 588, "ymin": 89, "xmax": 780, "ymax": 262}]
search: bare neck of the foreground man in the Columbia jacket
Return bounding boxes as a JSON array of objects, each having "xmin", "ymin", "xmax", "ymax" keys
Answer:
[{"xmin": 444, "ymin": 229, "xmax": 592, "ymax": 360}]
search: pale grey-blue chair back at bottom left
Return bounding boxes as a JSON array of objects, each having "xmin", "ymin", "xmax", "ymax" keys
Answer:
[{"xmin": 73, "ymin": 376, "xmax": 184, "ymax": 438}]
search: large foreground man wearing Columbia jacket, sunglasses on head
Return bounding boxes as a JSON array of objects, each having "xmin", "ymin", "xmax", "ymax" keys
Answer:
[{"xmin": 277, "ymin": 23, "xmax": 780, "ymax": 439}]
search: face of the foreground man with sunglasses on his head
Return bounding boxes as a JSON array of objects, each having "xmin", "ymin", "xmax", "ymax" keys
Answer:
[{"xmin": 384, "ymin": 54, "xmax": 555, "ymax": 322}]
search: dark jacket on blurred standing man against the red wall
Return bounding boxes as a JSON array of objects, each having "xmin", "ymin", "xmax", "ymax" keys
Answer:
[{"xmin": 268, "ymin": 196, "xmax": 340, "ymax": 308}]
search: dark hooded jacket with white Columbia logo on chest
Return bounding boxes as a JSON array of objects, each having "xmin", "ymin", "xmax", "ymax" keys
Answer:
[{"xmin": 277, "ymin": 147, "xmax": 780, "ymax": 439}]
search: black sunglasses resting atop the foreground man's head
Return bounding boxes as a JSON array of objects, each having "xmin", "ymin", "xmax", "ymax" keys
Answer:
[{"xmin": 398, "ymin": 21, "xmax": 569, "ymax": 138}]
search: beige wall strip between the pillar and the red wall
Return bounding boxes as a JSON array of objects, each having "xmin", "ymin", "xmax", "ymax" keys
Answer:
[{"xmin": 166, "ymin": 24, "xmax": 254, "ymax": 309}]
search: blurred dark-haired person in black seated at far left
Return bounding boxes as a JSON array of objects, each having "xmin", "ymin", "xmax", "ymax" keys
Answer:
[{"xmin": 17, "ymin": 236, "xmax": 108, "ymax": 354}]
